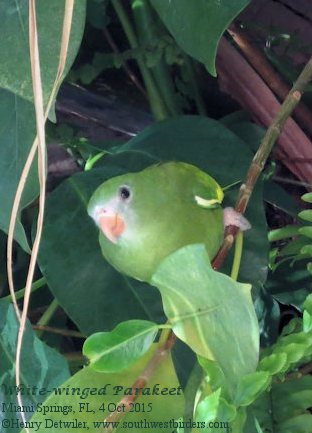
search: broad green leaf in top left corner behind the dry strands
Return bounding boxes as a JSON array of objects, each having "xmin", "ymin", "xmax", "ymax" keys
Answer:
[{"xmin": 0, "ymin": 0, "xmax": 86, "ymax": 101}]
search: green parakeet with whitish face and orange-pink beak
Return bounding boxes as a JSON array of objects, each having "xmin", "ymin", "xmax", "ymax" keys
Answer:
[{"xmin": 88, "ymin": 162, "xmax": 239, "ymax": 281}]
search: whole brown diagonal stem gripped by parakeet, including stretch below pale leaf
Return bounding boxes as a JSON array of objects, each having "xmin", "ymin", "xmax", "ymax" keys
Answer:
[{"xmin": 104, "ymin": 57, "xmax": 312, "ymax": 433}]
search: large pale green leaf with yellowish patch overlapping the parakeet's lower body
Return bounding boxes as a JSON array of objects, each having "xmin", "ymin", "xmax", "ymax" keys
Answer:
[{"xmin": 152, "ymin": 245, "xmax": 259, "ymax": 394}]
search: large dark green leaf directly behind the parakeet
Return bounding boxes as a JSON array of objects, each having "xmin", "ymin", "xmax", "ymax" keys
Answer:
[{"xmin": 39, "ymin": 116, "xmax": 268, "ymax": 333}]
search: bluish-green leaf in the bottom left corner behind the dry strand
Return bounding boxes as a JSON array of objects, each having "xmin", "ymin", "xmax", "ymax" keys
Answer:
[{"xmin": 0, "ymin": 300, "xmax": 69, "ymax": 433}]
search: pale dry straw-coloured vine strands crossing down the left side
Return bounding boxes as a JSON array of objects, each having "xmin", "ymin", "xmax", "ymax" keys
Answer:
[{"xmin": 11, "ymin": 0, "xmax": 74, "ymax": 433}]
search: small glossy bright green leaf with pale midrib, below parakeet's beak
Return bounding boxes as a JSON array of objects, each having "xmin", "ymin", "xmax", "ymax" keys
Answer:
[{"xmin": 83, "ymin": 320, "xmax": 158, "ymax": 373}]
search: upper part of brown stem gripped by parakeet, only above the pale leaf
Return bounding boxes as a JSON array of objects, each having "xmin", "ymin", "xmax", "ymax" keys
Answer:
[{"xmin": 213, "ymin": 57, "xmax": 312, "ymax": 269}]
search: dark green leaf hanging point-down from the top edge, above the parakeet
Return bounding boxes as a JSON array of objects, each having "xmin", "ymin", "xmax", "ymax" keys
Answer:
[{"xmin": 151, "ymin": 0, "xmax": 249, "ymax": 75}]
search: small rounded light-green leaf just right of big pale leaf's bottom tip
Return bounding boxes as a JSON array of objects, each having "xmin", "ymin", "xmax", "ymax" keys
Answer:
[{"xmin": 234, "ymin": 371, "xmax": 271, "ymax": 406}]
